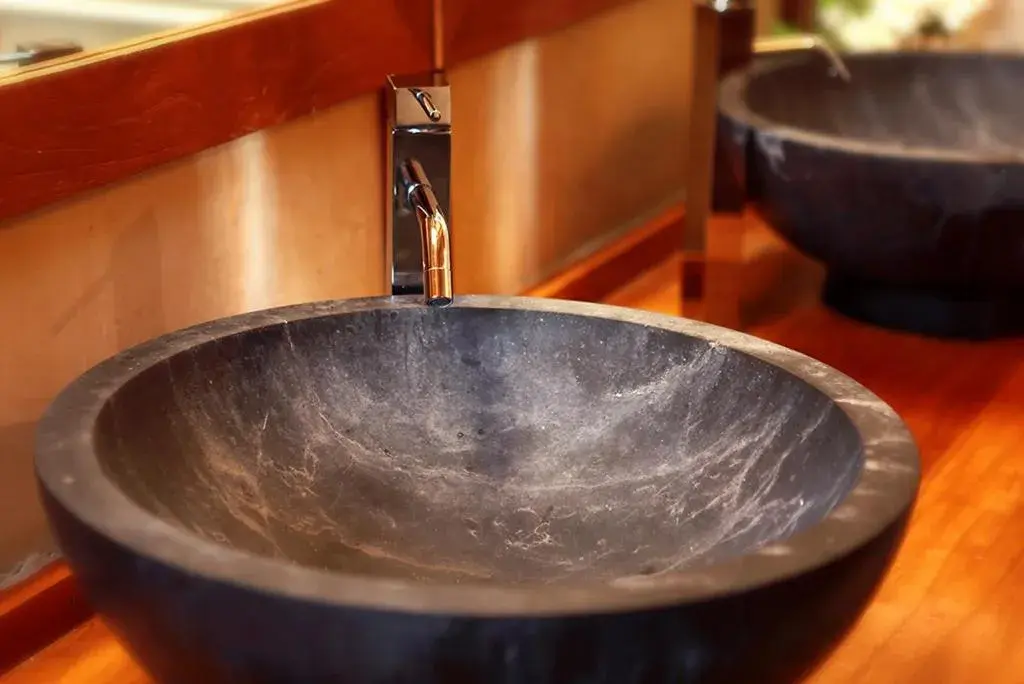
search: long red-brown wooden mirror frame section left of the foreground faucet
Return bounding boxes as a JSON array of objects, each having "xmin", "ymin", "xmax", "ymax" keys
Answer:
[{"xmin": 0, "ymin": 0, "xmax": 433, "ymax": 224}]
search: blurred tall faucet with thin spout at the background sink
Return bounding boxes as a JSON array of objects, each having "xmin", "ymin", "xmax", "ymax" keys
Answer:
[{"xmin": 681, "ymin": 0, "xmax": 850, "ymax": 315}]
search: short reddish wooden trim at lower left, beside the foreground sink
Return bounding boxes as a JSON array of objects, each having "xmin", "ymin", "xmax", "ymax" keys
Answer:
[{"xmin": 0, "ymin": 562, "xmax": 92, "ymax": 676}]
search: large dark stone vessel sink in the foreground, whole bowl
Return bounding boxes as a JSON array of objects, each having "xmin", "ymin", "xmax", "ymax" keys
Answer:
[{"xmin": 37, "ymin": 297, "xmax": 919, "ymax": 684}]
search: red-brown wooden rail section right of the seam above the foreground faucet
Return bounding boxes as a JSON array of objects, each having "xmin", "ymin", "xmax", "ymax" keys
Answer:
[{"xmin": 439, "ymin": 0, "xmax": 631, "ymax": 67}]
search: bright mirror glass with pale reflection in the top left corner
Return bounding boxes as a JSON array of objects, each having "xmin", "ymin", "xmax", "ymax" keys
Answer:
[{"xmin": 0, "ymin": 0, "xmax": 289, "ymax": 75}]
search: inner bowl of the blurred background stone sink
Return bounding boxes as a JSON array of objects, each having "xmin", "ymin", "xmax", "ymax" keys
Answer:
[{"xmin": 746, "ymin": 53, "xmax": 1024, "ymax": 154}]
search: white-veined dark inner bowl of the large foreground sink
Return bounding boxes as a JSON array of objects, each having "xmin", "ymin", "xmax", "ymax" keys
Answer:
[{"xmin": 93, "ymin": 306, "xmax": 863, "ymax": 584}]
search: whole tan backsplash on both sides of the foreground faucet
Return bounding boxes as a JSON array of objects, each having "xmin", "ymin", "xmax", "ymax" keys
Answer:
[{"xmin": 0, "ymin": 0, "xmax": 704, "ymax": 584}]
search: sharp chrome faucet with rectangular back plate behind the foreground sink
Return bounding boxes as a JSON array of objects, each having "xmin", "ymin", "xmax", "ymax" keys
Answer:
[{"xmin": 384, "ymin": 72, "xmax": 453, "ymax": 306}]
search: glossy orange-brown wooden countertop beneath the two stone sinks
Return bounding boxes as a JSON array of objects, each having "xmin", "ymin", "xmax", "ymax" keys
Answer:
[{"xmin": 0, "ymin": 219, "xmax": 1024, "ymax": 684}]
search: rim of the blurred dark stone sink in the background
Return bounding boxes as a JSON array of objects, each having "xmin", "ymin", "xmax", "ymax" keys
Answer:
[{"xmin": 718, "ymin": 50, "xmax": 1024, "ymax": 165}]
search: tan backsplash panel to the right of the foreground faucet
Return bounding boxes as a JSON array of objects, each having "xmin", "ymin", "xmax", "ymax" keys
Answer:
[{"xmin": 445, "ymin": 0, "xmax": 692, "ymax": 294}]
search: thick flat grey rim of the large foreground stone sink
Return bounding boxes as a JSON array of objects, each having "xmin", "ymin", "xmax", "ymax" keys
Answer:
[{"xmin": 35, "ymin": 295, "xmax": 921, "ymax": 616}]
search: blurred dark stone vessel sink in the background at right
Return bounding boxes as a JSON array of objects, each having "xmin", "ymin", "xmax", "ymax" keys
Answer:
[{"xmin": 720, "ymin": 52, "xmax": 1024, "ymax": 338}]
